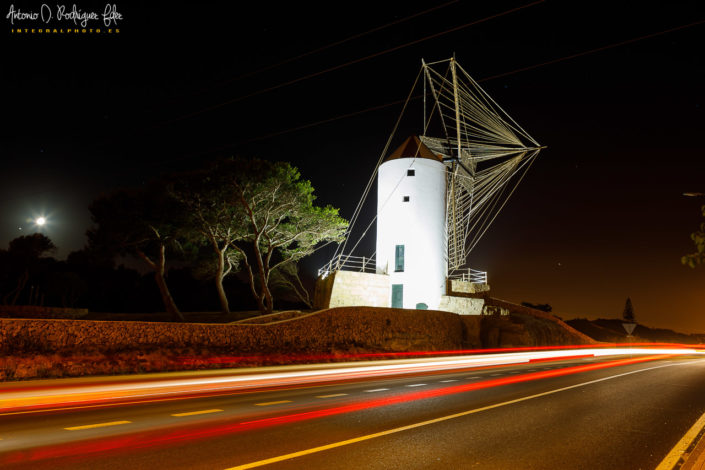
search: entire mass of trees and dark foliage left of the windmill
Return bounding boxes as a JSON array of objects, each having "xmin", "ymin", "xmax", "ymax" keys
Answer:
[{"xmin": 0, "ymin": 159, "xmax": 347, "ymax": 320}]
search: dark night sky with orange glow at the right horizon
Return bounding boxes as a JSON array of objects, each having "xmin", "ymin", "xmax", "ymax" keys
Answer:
[{"xmin": 0, "ymin": 0, "xmax": 705, "ymax": 332}]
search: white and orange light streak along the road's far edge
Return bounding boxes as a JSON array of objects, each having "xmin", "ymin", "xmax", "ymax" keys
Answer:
[{"xmin": 0, "ymin": 346, "xmax": 705, "ymax": 414}]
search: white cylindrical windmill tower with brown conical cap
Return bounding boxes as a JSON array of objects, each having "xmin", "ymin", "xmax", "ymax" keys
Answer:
[{"xmin": 376, "ymin": 136, "xmax": 448, "ymax": 309}]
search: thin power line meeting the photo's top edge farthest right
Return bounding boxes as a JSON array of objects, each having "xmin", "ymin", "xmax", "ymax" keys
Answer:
[{"xmin": 161, "ymin": 0, "xmax": 545, "ymax": 125}]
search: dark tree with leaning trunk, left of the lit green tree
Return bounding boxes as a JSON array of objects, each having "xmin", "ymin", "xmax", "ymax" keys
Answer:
[{"xmin": 87, "ymin": 183, "xmax": 185, "ymax": 321}]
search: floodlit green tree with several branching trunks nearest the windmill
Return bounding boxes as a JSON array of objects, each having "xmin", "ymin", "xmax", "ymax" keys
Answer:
[{"xmin": 173, "ymin": 158, "xmax": 348, "ymax": 313}]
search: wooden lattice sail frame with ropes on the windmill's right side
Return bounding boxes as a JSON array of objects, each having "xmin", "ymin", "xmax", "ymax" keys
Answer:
[{"xmin": 421, "ymin": 57, "xmax": 542, "ymax": 277}]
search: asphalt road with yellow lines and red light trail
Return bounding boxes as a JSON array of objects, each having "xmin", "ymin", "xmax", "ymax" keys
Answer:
[{"xmin": 0, "ymin": 356, "xmax": 705, "ymax": 470}]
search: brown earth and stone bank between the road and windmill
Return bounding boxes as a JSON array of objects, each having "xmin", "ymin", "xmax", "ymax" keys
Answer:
[{"xmin": 0, "ymin": 307, "xmax": 586, "ymax": 380}]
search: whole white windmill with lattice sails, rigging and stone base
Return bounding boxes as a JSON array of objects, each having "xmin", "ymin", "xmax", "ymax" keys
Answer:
[{"xmin": 319, "ymin": 57, "xmax": 542, "ymax": 309}]
